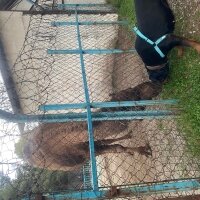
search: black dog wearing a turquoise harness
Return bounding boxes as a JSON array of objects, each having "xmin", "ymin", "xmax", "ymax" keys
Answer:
[{"xmin": 133, "ymin": 0, "xmax": 200, "ymax": 84}]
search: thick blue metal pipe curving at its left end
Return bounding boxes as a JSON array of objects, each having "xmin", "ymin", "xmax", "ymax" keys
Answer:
[{"xmin": 0, "ymin": 110, "xmax": 176, "ymax": 123}]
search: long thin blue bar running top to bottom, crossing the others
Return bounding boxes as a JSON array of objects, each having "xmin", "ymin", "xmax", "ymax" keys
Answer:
[{"xmin": 75, "ymin": 6, "xmax": 99, "ymax": 191}]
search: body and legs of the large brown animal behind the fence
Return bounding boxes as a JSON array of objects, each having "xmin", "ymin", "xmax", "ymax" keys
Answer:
[{"xmin": 23, "ymin": 126, "xmax": 152, "ymax": 171}]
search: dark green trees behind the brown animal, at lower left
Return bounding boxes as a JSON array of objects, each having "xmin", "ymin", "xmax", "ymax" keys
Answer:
[{"xmin": 12, "ymin": 136, "xmax": 83, "ymax": 196}]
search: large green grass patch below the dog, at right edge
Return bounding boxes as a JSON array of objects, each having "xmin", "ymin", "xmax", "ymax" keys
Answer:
[{"xmin": 162, "ymin": 49, "xmax": 200, "ymax": 156}]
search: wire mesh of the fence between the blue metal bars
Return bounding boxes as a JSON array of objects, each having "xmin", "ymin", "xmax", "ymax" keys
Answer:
[{"xmin": 0, "ymin": 1, "xmax": 200, "ymax": 200}]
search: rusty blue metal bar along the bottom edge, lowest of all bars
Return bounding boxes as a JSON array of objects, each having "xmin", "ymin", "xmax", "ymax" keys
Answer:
[{"xmin": 40, "ymin": 179, "xmax": 200, "ymax": 200}]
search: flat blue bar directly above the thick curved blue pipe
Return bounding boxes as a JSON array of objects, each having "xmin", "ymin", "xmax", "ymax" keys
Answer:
[{"xmin": 39, "ymin": 99, "xmax": 178, "ymax": 111}]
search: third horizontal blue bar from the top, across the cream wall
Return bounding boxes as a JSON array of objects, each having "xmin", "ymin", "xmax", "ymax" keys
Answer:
[{"xmin": 47, "ymin": 49, "xmax": 136, "ymax": 55}]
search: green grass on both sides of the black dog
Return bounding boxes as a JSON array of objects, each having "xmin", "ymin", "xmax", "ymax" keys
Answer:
[{"xmin": 108, "ymin": 0, "xmax": 200, "ymax": 156}]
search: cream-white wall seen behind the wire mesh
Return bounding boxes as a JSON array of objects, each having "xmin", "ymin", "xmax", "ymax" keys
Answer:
[{"xmin": 13, "ymin": 12, "xmax": 121, "ymax": 113}]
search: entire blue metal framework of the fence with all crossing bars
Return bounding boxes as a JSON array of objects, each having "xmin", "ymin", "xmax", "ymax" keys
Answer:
[{"xmin": 0, "ymin": 1, "xmax": 200, "ymax": 200}]
